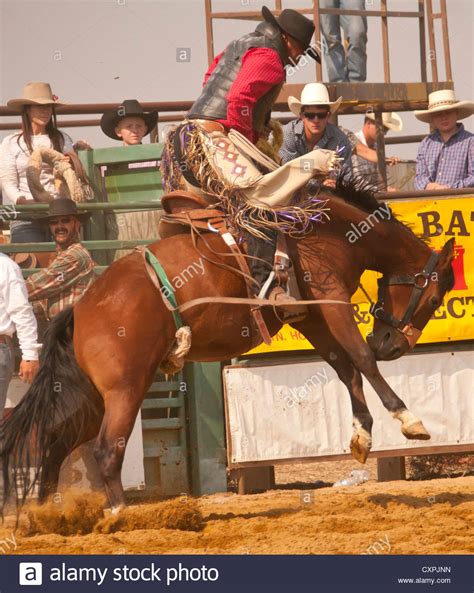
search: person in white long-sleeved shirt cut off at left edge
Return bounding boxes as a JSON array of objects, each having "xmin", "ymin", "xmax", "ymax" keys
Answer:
[{"xmin": 0, "ymin": 253, "xmax": 39, "ymax": 419}]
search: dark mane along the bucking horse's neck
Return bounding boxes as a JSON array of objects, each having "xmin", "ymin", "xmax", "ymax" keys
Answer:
[{"xmin": 331, "ymin": 173, "xmax": 431, "ymax": 247}]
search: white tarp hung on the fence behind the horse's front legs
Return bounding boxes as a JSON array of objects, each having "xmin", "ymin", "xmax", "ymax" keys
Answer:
[{"xmin": 224, "ymin": 352, "xmax": 474, "ymax": 464}]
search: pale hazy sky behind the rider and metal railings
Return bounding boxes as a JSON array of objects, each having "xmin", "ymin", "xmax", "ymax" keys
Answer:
[{"xmin": 0, "ymin": 0, "xmax": 474, "ymax": 158}]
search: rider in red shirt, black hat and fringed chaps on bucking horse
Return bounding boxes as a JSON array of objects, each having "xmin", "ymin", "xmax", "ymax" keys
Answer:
[{"xmin": 162, "ymin": 7, "xmax": 340, "ymax": 319}]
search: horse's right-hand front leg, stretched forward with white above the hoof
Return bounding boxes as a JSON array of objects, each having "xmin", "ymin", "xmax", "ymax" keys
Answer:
[{"xmin": 312, "ymin": 305, "xmax": 431, "ymax": 440}]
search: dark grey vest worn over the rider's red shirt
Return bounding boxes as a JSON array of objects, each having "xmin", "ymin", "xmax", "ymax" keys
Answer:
[{"xmin": 188, "ymin": 22, "xmax": 290, "ymax": 132}]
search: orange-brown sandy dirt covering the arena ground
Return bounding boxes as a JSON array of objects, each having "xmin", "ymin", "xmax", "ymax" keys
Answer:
[{"xmin": 0, "ymin": 472, "xmax": 474, "ymax": 554}]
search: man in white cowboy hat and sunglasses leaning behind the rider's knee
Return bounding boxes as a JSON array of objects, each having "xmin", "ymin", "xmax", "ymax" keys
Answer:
[{"xmin": 280, "ymin": 82, "xmax": 352, "ymax": 186}]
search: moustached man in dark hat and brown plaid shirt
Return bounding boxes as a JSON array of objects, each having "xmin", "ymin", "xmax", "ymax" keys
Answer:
[{"xmin": 26, "ymin": 198, "xmax": 94, "ymax": 320}]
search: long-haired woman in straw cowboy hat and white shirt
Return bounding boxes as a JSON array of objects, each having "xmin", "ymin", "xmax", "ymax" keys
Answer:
[{"xmin": 0, "ymin": 82, "xmax": 73, "ymax": 243}]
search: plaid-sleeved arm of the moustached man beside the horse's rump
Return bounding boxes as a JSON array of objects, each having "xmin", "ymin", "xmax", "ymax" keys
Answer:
[{"xmin": 26, "ymin": 246, "xmax": 86, "ymax": 301}]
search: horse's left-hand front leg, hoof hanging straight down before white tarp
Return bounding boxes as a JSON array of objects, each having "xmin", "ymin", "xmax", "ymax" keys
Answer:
[{"xmin": 294, "ymin": 322, "xmax": 374, "ymax": 463}]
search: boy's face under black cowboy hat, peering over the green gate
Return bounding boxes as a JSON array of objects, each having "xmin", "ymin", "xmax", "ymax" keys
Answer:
[{"xmin": 100, "ymin": 99, "xmax": 158, "ymax": 146}]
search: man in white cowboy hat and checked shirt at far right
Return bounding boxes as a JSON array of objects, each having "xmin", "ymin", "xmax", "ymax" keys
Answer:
[{"xmin": 415, "ymin": 89, "xmax": 474, "ymax": 189}]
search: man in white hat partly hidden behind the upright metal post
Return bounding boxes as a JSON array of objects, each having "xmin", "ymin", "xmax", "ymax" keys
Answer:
[{"xmin": 348, "ymin": 112, "xmax": 403, "ymax": 187}]
